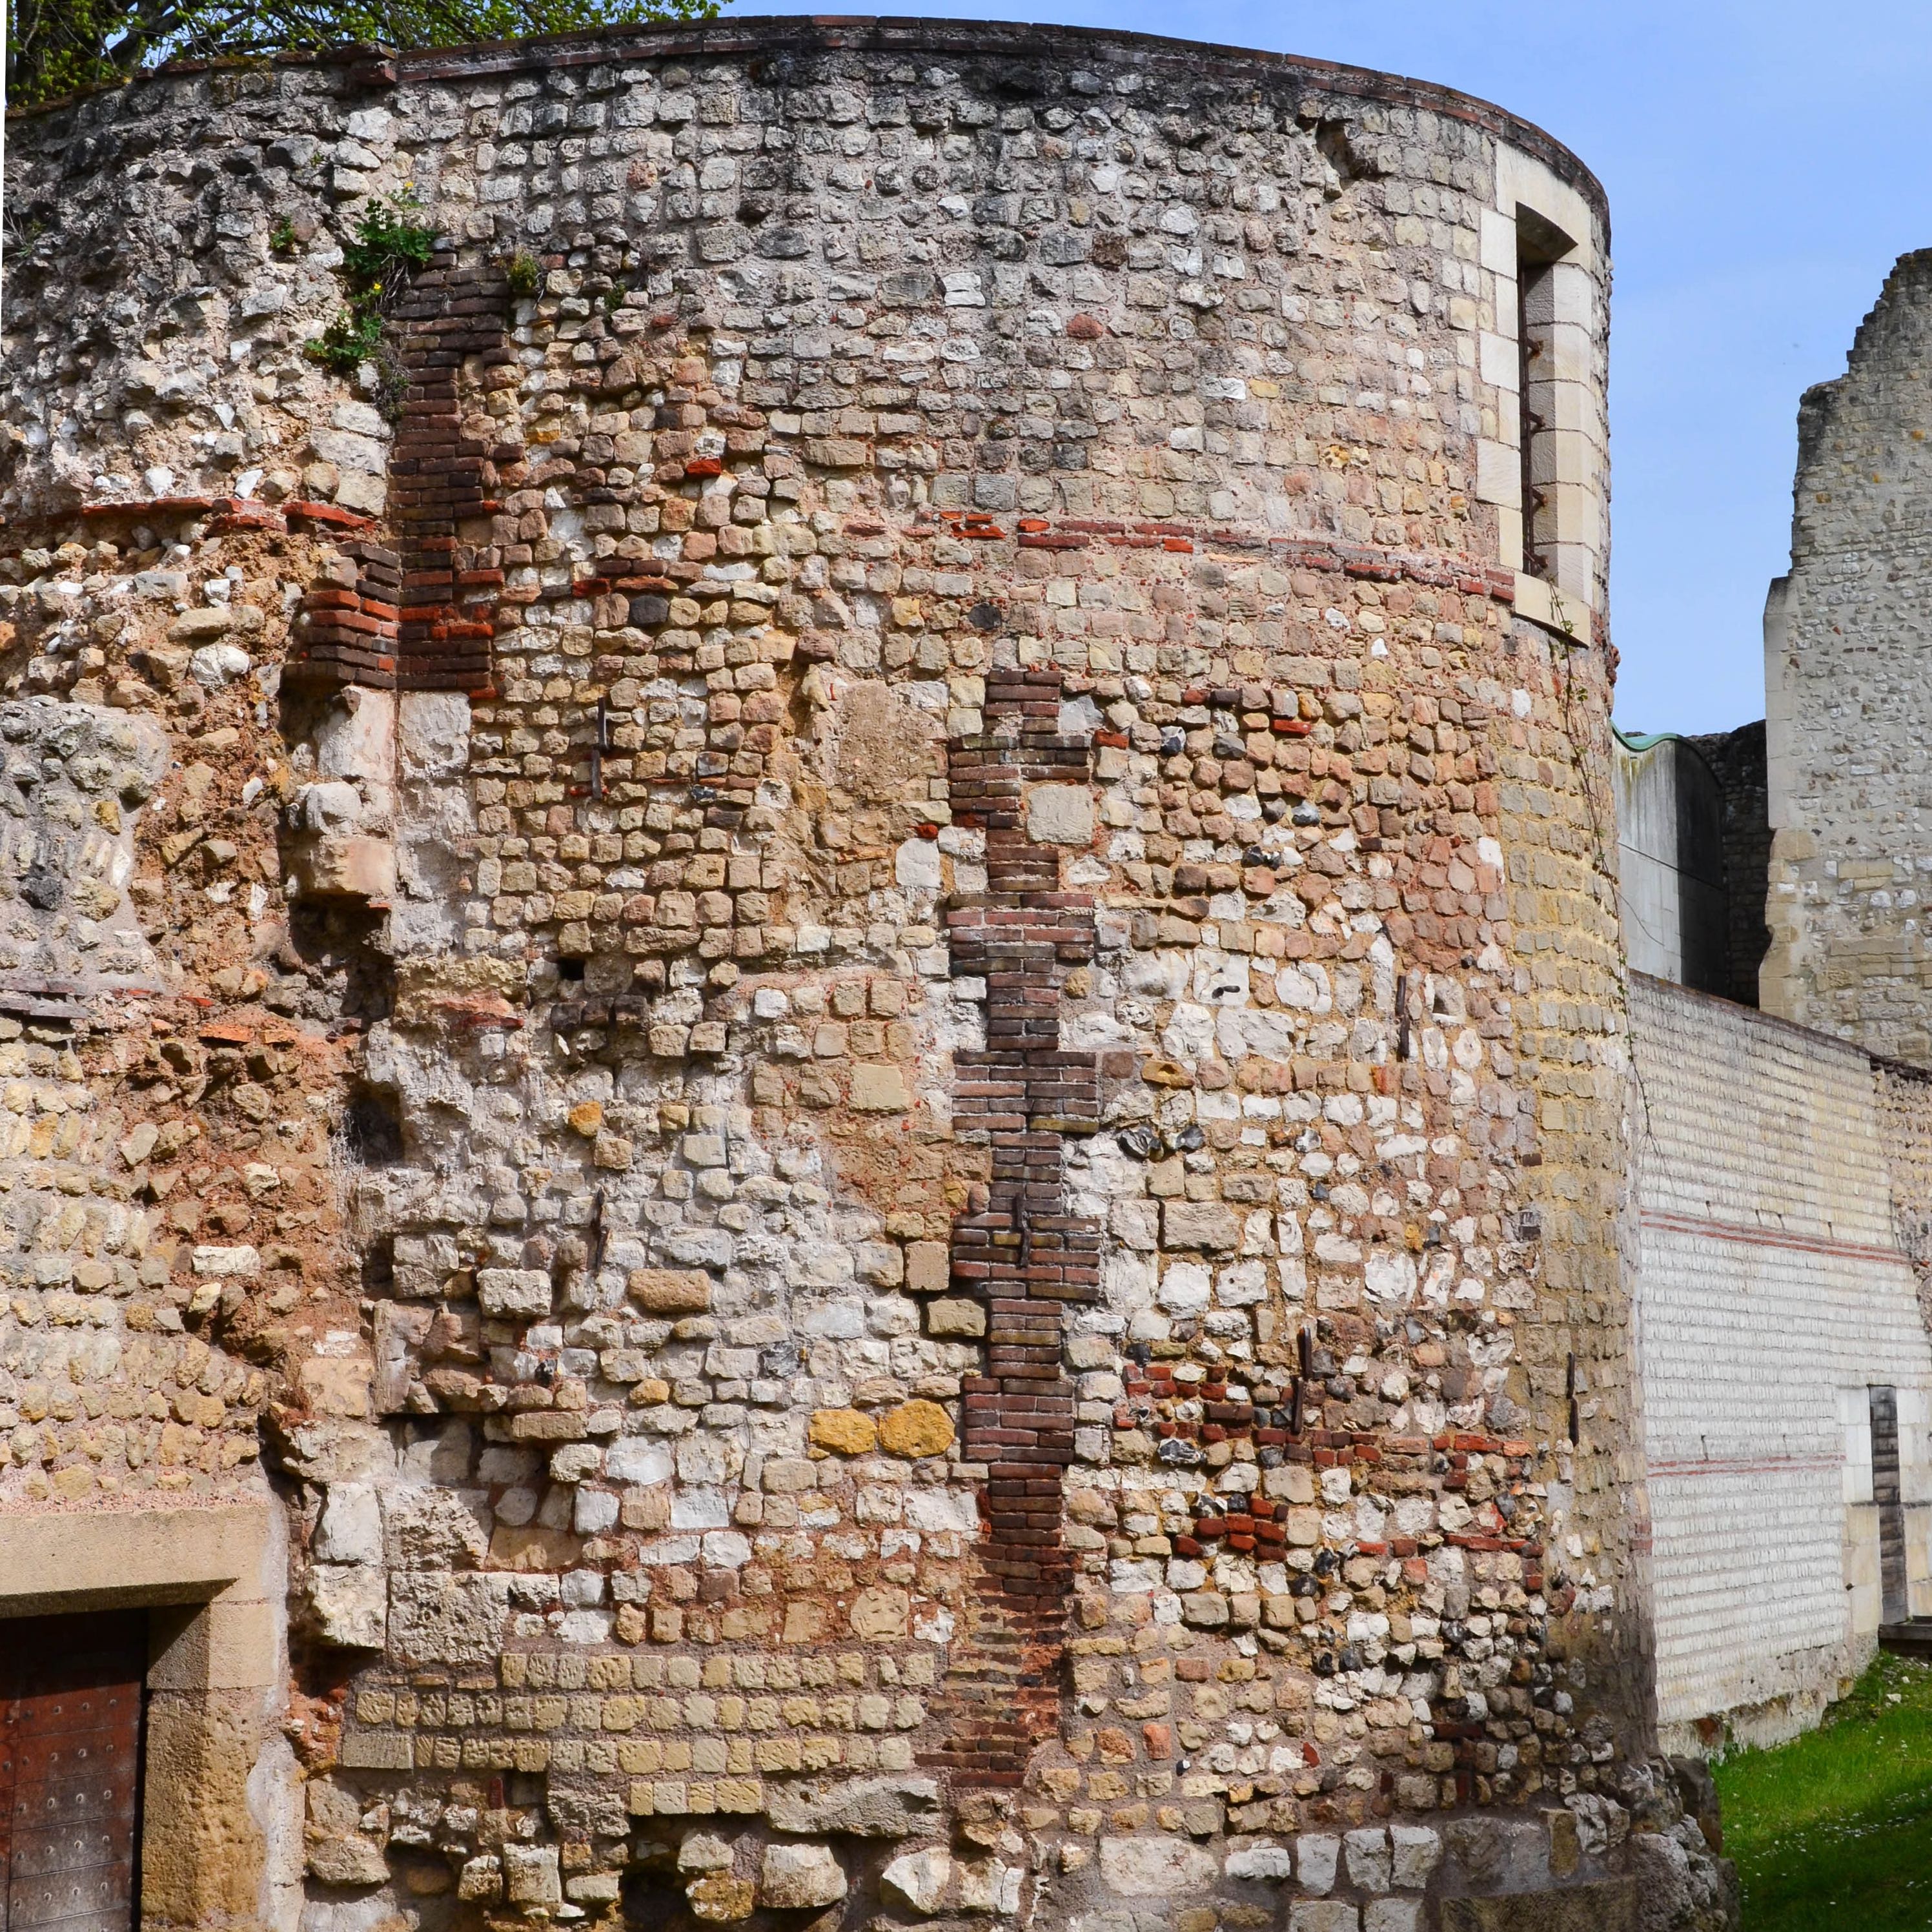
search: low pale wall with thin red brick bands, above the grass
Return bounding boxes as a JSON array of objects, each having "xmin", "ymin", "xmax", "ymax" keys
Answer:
[{"xmin": 1631, "ymin": 973, "xmax": 1932, "ymax": 1753}]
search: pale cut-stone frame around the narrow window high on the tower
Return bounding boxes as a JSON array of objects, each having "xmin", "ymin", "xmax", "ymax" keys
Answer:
[{"xmin": 1476, "ymin": 145, "xmax": 1609, "ymax": 636}]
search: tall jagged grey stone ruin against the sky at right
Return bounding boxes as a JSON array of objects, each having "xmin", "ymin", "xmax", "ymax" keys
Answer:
[{"xmin": 1760, "ymin": 253, "xmax": 1932, "ymax": 1064}]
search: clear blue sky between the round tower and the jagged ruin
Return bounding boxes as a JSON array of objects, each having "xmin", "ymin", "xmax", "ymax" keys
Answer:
[{"xmin": 734, "ymin": 0, "xmax": 1932, "ymax": 730}]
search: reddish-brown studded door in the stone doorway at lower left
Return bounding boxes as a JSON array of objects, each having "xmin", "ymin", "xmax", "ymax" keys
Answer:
[{"xmin": 0, "ymin": 1611, "xmax": 147, "ymax": 1932}]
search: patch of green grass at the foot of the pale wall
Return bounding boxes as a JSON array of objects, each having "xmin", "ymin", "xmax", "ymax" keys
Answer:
[{"xmin": 1716, "ymin": 1656, "xmax": 1932, "ymax": 1932}]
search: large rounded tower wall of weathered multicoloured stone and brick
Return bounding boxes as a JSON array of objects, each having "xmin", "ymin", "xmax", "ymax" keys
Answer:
[{"xmin": 0, "ymin": 21, "xmax": 1725, "ymax": 1932}]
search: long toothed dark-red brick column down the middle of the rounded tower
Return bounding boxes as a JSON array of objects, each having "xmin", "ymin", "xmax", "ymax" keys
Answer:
[{"xmin": 930, "ymin": 671, "xmax": 1101, "ymax": 1785}]
